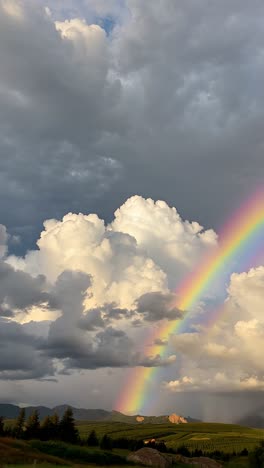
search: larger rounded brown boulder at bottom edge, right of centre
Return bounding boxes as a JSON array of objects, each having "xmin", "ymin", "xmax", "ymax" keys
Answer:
[{"xmin": 127, "ymin": 447, "xmax": 173, "ymax": 468}]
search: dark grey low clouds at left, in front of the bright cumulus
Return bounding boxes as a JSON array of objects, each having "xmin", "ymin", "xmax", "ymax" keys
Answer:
[{"xmin": 0, "ymin": 262, "xmax": 177, "ymax": 380}]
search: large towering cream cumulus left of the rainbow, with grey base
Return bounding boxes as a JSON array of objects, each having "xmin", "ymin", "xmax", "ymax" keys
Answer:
[{"xmin": 0, "ymin": 197, "xmax": 216, "ymax": 378}]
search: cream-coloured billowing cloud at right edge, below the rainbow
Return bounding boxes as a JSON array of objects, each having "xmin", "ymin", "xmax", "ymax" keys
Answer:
[{"xmin": 165, "ymin": 267, "xmax": 264, "ymax": 392}]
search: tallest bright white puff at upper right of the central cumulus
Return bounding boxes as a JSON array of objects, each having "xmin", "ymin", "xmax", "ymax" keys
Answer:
[{"xmin": 111, "ymin": 196, "xmax": 217, "ymax": 282}]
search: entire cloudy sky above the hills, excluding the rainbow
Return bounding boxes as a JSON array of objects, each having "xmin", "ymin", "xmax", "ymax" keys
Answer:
[{"xmin": 0, "ymin": 0, "xmax": 264, "ymax": 422}]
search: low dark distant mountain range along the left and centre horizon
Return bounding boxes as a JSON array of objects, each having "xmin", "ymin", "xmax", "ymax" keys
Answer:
[{"xmin": 0, "ymin": 403, "xmax": 198, "ymax": 424}]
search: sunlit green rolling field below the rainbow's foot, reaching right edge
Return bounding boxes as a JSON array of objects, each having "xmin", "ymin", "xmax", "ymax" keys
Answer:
[{"xmin": 77, "ymin": 421, "xmax": 264, "ymax": 454}]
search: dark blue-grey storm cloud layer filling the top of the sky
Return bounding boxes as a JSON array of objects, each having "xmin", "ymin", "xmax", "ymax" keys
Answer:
[{"xmin": 0, "ymin": 0, "xmax": 264, "ymax": 249}]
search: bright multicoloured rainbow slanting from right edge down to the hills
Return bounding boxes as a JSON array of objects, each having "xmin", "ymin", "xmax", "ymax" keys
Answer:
[{"xmin": 116, "ymin": 189, "xmax": 264, "ymax": 414}]
